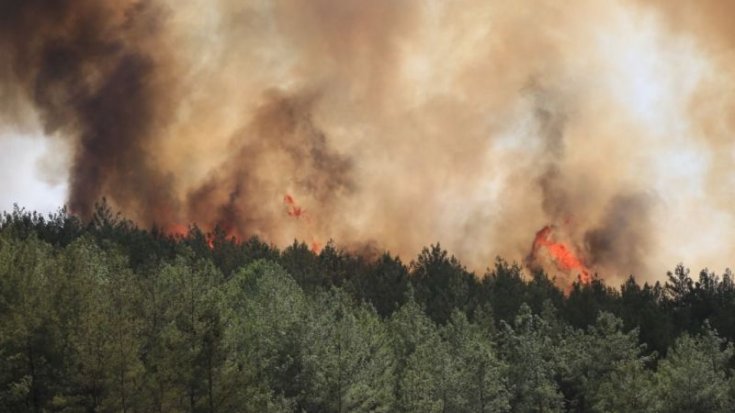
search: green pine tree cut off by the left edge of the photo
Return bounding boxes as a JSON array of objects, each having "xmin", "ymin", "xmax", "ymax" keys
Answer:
[{"xmin": 0, "ymin": 231, "xmax": 56, "ymax": 412}]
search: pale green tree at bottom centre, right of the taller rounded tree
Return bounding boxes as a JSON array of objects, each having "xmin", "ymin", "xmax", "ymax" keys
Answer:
[{"xmin": 302, "ymin": 290, "xmax": 395, "ymax": 413}]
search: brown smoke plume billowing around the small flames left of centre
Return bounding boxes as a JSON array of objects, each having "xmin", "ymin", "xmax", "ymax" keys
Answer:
[{"xmin": 188, "ymin": 91, "xmax": 353, "ymax": 237}]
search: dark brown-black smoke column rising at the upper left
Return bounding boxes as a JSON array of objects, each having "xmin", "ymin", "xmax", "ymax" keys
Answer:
[{"xmin": 0, "ymin": 0, "xmax": 173, "ymax": 224}]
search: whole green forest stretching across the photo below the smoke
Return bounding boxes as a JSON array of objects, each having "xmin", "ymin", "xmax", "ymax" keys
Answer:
[{"xmin": 0, "ymin": 205, "xmax": 735, "ymax": 412}]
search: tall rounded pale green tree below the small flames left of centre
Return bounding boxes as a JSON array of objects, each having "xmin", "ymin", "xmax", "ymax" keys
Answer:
[{"xmin": 223, "ymin": 260, "xmax": 308, "ymax": 411}]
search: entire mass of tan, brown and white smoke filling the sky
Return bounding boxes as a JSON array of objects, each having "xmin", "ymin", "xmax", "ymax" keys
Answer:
[{"xmin": 0, "ymin": 0, "xmax": 735, "ymax": 284}]
